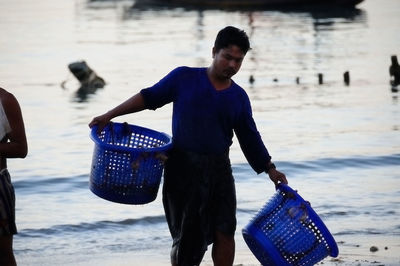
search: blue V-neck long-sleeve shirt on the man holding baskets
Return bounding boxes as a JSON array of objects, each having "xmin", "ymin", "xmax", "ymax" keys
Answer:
[{"xmin": 141, "ymin": 67, "xmax": 271, "ymax": 173}]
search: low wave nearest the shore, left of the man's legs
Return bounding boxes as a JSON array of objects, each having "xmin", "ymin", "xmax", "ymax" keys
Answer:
[{"xmin": 18, "ymin": 215, "xmax": 165, "ymax": 238}]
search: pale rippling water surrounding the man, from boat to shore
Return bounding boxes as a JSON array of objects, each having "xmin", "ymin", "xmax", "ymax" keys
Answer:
[{"xmin": 0, "ymin": 0, "xmax": 400, "ymax": 265}]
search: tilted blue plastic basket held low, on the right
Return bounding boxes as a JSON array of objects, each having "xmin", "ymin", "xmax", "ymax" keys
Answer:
[{"xmin": 242, "ymin": 184, "xmax": 339, "ymax": 266}]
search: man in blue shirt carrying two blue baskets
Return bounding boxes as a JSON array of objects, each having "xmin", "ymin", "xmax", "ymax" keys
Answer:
[{"xmin": 89, "ymin": 26, "xmax": 287, "ymax": 266}]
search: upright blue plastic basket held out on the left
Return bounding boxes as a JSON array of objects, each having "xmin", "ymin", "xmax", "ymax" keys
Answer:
[{"xmin": 90, "ymin": 123, "xmax": 172, "ymax": 204}]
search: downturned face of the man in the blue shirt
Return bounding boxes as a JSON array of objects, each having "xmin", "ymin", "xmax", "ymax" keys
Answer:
[{"xmin": 213, "ymin": 45, "xmax": 245, "ymax": 79}]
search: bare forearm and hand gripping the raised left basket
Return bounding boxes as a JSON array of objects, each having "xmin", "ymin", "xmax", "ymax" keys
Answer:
[{"xmin": 89, "ymin": 93, "xmax": 146, "ymax": 131}]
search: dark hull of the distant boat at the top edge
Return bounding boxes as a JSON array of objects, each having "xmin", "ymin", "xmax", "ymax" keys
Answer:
[{"xmin": 152, "ymin": 0, "xmax": 364, "ymax": 7}]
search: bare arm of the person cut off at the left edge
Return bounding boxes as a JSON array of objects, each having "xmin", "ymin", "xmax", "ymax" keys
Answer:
[{"xmin": 0, "ymin": 93, "xmax": 28, "ymax": 158}]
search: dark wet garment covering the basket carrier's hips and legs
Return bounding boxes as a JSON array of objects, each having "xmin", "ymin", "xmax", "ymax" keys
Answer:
[{"xmin": 163, "ymin": 150, "xmax": 236, "ymax": 266}]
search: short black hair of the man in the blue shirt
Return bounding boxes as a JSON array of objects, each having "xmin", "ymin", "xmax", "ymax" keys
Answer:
[{"xmin": 214, "ymin": 26, "xmax": 250, "ymax": 54}]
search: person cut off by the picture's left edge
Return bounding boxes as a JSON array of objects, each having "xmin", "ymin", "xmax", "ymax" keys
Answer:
[{"xmin": 0, "ymin": 88, "xmax": 28, "ymax": 265}]
